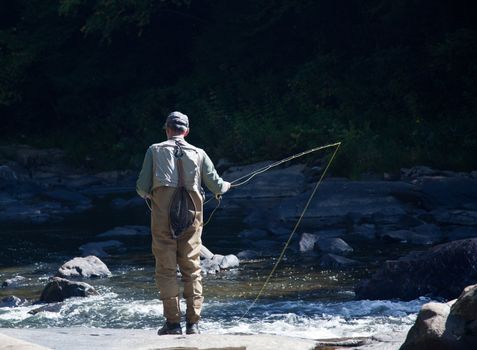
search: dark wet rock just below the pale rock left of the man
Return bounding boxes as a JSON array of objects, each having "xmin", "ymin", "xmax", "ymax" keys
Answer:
[{"xmin": 40, "ymin": 277, "xmax": 98, "ymax": 303}]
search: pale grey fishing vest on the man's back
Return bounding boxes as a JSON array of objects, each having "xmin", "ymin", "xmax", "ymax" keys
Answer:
[{"xmin": 151, "ymin": 137, "xmax": 204, "ymax": 193}]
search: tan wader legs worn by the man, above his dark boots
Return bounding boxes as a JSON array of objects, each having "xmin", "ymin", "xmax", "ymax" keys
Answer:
[{"xmin": 151, "ymin": 186, "xmax": 203, "ymax": 324}]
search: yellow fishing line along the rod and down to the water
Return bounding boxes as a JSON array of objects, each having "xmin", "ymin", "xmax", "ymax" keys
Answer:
[{"xmin": 236, "ymin": 142, "xmax": 341, "ymax": 322}]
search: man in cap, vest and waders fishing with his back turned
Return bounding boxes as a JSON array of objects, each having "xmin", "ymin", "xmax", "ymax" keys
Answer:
[{"xmin": 136, "ymin": 112, "xmax": 230, "ymax": 335}]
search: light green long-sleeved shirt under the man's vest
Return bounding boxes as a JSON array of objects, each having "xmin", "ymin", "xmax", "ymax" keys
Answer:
[{"xmin": 136, "ymin": 139, "xmax": 227, "ymax": 198}]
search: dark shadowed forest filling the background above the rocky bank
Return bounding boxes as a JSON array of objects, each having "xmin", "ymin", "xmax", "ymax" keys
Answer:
[{"xmin": 0, "ymin": 0, "xmax": 477, "ymax": 177}]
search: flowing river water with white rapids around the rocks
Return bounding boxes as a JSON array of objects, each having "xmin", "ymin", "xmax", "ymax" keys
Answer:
[{"xmin": 0, "ymin": 198, "xmax": 428, "ymax": 339}]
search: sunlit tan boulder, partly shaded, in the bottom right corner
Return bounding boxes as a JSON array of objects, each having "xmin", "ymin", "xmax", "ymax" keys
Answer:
[{"xmin": 401, "ymin": 285, "xmax": 477, "ymax": 350}]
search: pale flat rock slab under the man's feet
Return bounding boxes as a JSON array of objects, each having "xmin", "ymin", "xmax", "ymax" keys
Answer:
[{"xmin": 0, "ymin": 327, "xmax": 316, "ymax": 350}]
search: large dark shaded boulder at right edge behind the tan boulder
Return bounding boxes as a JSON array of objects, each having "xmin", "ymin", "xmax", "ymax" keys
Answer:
[{"xmin": 356, "ymin": 238, "xmax": 477, "ymax": 300}]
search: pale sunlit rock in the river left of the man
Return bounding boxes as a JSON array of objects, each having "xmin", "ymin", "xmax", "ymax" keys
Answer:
[{"xmin": 56, "ymin": 255, "xmax": 111, "ymax": 278}]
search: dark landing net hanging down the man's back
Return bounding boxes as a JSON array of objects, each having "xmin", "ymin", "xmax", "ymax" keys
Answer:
[{"xmin": 169, "ymin": 141, "xmax": 197, "ymax": 239}]
